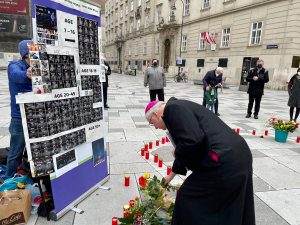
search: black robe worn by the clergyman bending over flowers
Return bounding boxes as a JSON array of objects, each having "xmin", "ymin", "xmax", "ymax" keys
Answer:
[{"xmin": 162, "ymin": 98, "xmax": 255, "ymax": 225}]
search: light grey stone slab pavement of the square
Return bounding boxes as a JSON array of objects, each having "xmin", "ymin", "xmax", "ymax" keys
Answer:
[{"xmin": 0, "ymin": 71, "xmax": 300, "ymax": 225}]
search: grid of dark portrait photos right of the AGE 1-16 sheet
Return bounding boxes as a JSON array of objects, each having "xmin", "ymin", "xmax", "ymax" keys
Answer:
[{"xmin": 77, "ymin": 17, "xmax": 100, "ymax": 65}]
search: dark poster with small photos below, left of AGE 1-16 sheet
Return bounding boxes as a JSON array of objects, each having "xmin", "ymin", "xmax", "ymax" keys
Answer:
[{"xmin": 36, "ymin": 5, "xmax": 58, "ymax": 46}]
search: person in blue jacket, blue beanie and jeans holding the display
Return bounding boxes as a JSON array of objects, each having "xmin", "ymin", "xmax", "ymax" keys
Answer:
[{"xmin": 3, "ymin": 40, "xmax": 33, "ymax": 180}]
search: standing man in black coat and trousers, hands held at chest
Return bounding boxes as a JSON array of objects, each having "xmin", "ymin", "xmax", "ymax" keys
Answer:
[{"xmin": 246, "ymin": 60, "xmax": 269, "ymax": 119}]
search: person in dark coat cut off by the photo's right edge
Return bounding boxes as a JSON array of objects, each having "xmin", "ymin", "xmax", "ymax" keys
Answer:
[{"xmin": 288, "ymin": 68, "xmax": 300, "ymax": 122}]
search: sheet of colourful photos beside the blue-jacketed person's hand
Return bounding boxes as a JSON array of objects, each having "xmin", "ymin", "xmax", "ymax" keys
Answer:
[{"xmin": 28, "ymin": 43, "xmax": 52, "ymax": 94}]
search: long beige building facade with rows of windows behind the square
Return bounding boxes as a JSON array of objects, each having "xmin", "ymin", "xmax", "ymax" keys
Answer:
[{"xmin": 105, "ymin": 0, "xmax": 300, "ymax": 89}]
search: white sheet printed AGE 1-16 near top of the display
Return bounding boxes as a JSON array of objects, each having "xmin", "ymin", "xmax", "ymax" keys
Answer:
[{"xmin": 57, "ymin": 11, "xmax": 78, "ymax": 48}]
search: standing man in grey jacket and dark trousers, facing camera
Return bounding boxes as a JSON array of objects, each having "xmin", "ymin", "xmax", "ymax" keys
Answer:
[{"xmin": 144, "ymin": 59, "xmax": 167, "ymax": 102}]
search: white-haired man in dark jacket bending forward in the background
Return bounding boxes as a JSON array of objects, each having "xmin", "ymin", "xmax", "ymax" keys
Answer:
[{"xmin": 202, "ymin": 67, "xmax": 223, "ymax": 116}]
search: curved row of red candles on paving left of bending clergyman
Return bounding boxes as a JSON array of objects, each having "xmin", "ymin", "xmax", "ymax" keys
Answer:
[{"xmin": 125, "ymin": 137, "xmax": 172, "ymax": 187}]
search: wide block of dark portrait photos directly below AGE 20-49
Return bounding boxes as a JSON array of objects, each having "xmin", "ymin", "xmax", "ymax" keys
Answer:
[{"xmin": 24, "ymin": 98, "xmax": 103, "ymax": 139}]
